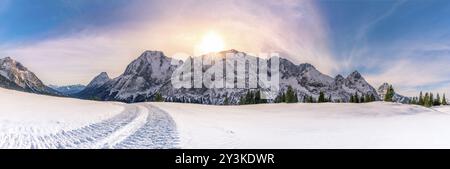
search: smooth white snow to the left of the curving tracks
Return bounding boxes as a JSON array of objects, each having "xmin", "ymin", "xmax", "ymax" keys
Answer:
[{"xmin": 0, "ymin": 88, "xmax": 124, "ymax": 134}]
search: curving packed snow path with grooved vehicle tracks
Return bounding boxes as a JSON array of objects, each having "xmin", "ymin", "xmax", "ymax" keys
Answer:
[{"xmin": 0, "ymin": 104, "xmax": 179, "ymax": 149}]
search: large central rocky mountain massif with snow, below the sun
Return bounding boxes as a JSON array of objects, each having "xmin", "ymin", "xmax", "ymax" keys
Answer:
[{"xmin": 78, "ymin": 50, "xmax": 379, "ymax": 104}]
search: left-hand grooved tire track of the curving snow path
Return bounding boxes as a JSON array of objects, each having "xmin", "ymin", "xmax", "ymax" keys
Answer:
[{"xmin": 0, "ymin": 105, "xmax": 139, "ymax": 149}]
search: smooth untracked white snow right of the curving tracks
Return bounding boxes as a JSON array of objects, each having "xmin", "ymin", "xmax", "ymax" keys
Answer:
[{"xmin": 151, "ymin": 102, "xmax": 450, "ymax": 148}]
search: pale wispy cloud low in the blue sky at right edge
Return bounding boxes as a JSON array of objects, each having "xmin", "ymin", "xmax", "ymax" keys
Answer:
[{"xmin": 367, "ymin": 42, "xmax": 450, "ymax": 96}]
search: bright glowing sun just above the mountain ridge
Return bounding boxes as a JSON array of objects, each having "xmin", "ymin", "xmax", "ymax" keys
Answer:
[{"xmin": 196, "ymin": 31, "xmax": 225, "ymax": 54}]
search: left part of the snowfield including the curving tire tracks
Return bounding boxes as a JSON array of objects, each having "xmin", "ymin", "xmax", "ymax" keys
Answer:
[{"xmin": 0, "ymin": 89, "xmax": 178, "ymax": 149}]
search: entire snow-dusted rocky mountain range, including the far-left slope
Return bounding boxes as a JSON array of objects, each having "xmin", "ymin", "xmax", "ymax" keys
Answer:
[{"xmin": 0, "ymin": 50, "xmax": 428, "ymax": 105}]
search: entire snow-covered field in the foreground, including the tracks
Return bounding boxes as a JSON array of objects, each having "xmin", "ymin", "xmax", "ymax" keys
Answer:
[{"xmin": 0, "ymin": 88, "xmax": 450, "ymax": 148}]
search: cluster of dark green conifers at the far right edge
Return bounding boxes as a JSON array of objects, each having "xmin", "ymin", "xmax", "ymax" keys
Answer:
[{"xmin": 410, "ymin": 92, "xmax": 448, "ymax": 107}]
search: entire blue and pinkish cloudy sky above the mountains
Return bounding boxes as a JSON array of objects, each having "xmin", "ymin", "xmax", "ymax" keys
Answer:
[{"xmin": 0, "ymin": 0, "xmax": 450, "ymax": 96}]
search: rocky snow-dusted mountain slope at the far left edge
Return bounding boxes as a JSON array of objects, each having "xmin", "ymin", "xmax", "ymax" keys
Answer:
[{"xmin": 0, "ymin": 57, "xmax": 60, "ymax": 95}]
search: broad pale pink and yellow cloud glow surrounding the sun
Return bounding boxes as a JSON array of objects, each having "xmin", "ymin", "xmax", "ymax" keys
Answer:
[{"xmin": 0, "ymin": 0, "xmax": 336, "ymax": 84}]
